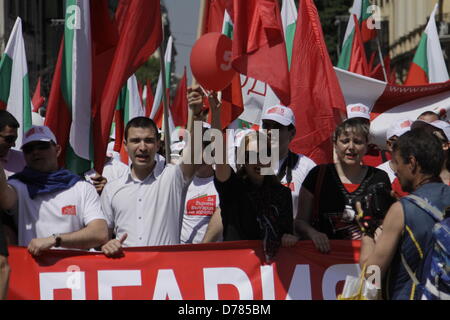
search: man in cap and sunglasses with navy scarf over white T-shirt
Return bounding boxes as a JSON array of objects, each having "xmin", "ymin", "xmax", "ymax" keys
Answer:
[{"xmin": 0, "ymin": 126, "xmax": 108, "ymax": 256}]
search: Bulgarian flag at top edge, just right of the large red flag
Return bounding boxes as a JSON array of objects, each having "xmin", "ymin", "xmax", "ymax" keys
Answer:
[{"xmin": 337, "ymin": 0, "xmax": 376, "ymax": 74}]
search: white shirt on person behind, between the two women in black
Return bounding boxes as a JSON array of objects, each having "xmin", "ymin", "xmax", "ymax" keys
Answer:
[{"xmin": 275, "ymin": 154, "xmax": 316, "ymax": 219}]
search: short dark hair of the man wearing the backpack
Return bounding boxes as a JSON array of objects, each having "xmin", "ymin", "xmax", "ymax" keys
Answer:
[{"xmin": 393, "ymin": 128, "xmax": 444, "ymax": 177}]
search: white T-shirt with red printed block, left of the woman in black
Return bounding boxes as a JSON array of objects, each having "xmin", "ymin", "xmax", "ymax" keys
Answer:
[{"xmin": 181, "ymin": 175, "xmax": 220, "ymax": 244}]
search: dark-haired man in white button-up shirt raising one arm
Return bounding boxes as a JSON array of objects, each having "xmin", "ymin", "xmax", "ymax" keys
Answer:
[{"xmin": 101, "ymin": 88, "xmax": 203, "ymax": 256}]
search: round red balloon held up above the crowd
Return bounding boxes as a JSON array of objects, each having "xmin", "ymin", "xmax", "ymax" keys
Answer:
[{"xmin": 191, "ymin": 32, "xmax": 236, "ymax": 91}]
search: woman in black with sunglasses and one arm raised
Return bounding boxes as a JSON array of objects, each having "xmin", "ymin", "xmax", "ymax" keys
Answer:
[{"xmin": 210, "ymin": 96, "xmax": 293, "ymax": 260}]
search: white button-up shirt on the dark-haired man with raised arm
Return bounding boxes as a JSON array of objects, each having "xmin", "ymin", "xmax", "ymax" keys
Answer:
[{"xmin": 101, "ymin": 161, "xmax": 190, "ymax": 247}]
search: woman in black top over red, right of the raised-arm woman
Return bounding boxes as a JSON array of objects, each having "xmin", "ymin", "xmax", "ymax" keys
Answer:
[{"xmin": 295, "ymin": 118, "xmax": 394, "ymax": 253}]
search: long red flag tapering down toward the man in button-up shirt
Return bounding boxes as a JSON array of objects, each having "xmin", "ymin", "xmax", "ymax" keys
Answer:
[{"xmin": 94, "ymin": 0, "xmax": 162, "ymax": 173}]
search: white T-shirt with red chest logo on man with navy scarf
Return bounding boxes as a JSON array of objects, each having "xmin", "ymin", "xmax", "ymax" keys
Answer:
[{"xmin": 8, "ymin": 179, "xmax": 105, "ymax": 246}]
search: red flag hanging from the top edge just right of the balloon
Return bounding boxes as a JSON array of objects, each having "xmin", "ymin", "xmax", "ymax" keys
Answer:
[{"xmin": 232, "ymin": 0, "xmax": 290, "ymax": 105}]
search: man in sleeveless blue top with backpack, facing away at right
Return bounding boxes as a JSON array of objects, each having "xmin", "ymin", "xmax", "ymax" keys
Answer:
[{"xmin": 360, "ymin": 126, "xmax": 450, "ymax": 300}]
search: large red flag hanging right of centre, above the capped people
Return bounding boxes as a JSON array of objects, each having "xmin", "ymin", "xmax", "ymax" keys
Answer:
[{"xmin": 291, "ymin": 0, "xmax": 345, "ymax": 164}]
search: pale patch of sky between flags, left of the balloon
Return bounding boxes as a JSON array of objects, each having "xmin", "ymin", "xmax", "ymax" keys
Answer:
[{"xmin": 163, "ymin": 0, "xmax": 200, "ymax": 83}]
